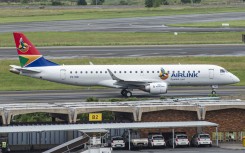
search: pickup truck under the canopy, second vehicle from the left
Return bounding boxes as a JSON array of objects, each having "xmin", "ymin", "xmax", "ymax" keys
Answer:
[{"xmin": 123, "ymin": 131, "xmax": 148, "ymax": 148}]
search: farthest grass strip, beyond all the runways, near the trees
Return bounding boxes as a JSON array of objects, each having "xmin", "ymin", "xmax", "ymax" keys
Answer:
[{"xmin": 0, "ymin": 6, "xmax": 244, "ymax": 24}]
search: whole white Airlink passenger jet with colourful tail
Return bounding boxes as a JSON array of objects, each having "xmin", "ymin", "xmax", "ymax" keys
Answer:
[{"xmin": 10, "ymin": 32, "xmax": 240, "ymax": 97}]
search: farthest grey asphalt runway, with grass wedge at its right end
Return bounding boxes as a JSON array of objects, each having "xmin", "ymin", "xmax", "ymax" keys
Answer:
[{"xmin": 0, "ymin": 12, "xmax": 245, "ymax": 33}]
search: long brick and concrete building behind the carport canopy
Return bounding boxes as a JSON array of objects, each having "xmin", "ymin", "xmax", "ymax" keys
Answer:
[{"xmin": 0, "ymin": 99, "xmax": 245, "ymax": 149}]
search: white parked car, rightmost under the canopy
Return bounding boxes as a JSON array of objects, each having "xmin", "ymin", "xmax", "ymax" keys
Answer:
[{"xmin": 191, "ymin": 134, "xmax": 212, "ymax": 147}]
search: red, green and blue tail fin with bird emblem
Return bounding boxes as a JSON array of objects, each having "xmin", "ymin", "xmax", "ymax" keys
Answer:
[{"xmin": 13, "ymin": 32, "xmax": 58, "ymax": 67}]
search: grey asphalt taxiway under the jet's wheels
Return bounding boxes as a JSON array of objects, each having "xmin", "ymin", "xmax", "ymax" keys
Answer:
[{"xmin": 0, "ymin": 86, "xmax": 245, "ymax": 104}]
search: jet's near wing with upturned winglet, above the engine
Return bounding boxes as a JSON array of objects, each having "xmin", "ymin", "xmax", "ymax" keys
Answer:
[{"xmin": 107, "ymin": 69, "xmax": 159, "ymax": 86}]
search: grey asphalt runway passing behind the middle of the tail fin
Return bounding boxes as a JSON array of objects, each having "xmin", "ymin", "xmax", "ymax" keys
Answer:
[{"xmin": 0, "ymin": 44, "xmax": 245, "ymax": 59}]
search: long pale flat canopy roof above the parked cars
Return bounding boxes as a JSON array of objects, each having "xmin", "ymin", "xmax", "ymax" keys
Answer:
[{"xmin": 0, "ymin": 121, "xmax": 218, "ymax": 133}]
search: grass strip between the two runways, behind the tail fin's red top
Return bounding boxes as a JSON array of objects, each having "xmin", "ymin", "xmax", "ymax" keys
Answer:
[{"xmin": 0, "ymin": 32, "xmax": 244, "ymax": 47}]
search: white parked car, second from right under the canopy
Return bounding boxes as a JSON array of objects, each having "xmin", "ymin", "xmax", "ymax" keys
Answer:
[{"xmin": 168, "ymin": 134, "xmax": 190, "ymax": 147}]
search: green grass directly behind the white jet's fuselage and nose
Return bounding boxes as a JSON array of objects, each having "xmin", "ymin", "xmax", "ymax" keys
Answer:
[{"xmin": 0, "ymin": 56, "xmax": 245, "ymax": 91}]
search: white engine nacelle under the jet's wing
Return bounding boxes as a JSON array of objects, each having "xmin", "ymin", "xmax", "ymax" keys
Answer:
[{"xmin": 145, "ymin": 82, "xmax": 168, "ymax": 94}]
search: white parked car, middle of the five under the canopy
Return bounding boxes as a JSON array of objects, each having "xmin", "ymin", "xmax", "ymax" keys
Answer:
[{"xmin": 148, "ymin": 134, "xmax": 166, "ymax": 147}]
